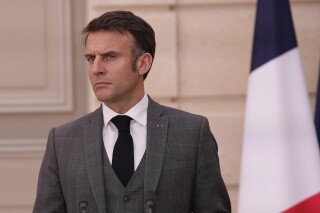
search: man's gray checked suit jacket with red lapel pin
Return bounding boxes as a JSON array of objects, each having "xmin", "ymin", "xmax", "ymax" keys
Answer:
[{"xmin": 33, "ymin": 98, "xmax": 231, "ymax": 213}]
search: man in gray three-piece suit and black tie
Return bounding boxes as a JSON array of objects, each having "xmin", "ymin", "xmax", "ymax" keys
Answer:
[{"xmin": 33, "ymin": 11, "xmax": 231, "ymax": 213}]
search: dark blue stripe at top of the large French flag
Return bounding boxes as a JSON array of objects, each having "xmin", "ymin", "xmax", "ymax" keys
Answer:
[{"xmin": 251, "ymin": 0, "xmax": 297, "ymax": 71}]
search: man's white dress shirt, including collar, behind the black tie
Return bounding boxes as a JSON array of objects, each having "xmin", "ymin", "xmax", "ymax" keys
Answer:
[{"xmin": 102, "ymin": 94, "xmax": 149, "ymax": 170}]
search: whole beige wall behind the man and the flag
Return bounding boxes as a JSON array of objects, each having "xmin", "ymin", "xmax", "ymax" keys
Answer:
[{"xmin": 0, "ymin": 0, "xmax": 320, "ymax": 213}]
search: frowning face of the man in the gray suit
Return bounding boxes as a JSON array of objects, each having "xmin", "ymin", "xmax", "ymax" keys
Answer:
[{"xmin": 85, "ymin": 31, "xmax": 144, "ymax": 108}]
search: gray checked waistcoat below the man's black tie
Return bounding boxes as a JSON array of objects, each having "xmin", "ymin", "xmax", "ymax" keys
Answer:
[{"xmin": 103, "ymin": 151, "xmax": 145, "ymax": 213}]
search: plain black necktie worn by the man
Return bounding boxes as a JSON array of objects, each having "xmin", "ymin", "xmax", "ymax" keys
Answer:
[{"xmin": 111, "ymin": 115, "xmax": 134, "ymax": 187}]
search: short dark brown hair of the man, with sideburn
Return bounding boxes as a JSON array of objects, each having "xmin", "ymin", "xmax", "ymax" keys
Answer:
[{"xmin": 82, "ymin": 11, "xmax": 156, "ymax": 79}]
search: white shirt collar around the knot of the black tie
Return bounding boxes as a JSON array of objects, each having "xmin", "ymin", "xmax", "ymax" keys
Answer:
[{"xmin": 102, "ymin": 94, "xmax": 149, "ymax": 126}]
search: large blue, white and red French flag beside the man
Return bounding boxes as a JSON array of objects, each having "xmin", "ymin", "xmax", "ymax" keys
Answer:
[{"xmin": 238, "ymin": 0, "xmax": 320, "ymax": 213}]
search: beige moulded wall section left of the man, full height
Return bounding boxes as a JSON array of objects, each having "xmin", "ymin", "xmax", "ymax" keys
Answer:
[{"xmin": 0, "ymin": 0, "xmax": 88, "ymax": 213}]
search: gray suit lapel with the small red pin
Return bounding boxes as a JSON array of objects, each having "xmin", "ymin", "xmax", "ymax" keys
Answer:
[{"xmin": 144, "ymin": 97, "xmax": 168, "ymax": 192}]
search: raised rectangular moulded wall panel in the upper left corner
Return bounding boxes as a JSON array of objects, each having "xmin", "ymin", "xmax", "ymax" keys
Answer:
[{"xmin": 0, "ymin": 0, "xmax": 73, "ymax": 113}]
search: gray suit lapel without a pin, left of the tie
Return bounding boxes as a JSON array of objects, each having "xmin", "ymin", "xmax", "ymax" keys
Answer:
[{"xmin": 83, "ymin": 107, "xmax": 106, "ymax": 213}]
